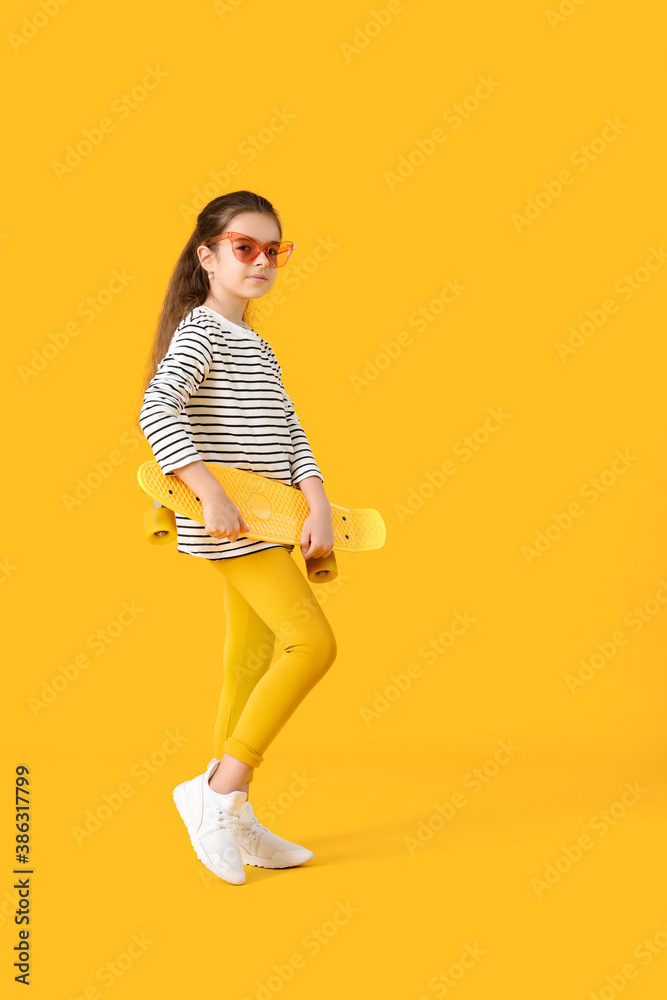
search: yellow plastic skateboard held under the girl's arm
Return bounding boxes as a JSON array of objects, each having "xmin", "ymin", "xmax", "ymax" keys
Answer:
[{"xmin": 137, "ymin": 461, "xmax": 386, "ymax": 583}]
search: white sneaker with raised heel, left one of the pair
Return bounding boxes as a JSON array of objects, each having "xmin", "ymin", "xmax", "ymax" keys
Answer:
[{"xmin": 172, "ymin": 757, "xmax": 249, "ymax": 885}]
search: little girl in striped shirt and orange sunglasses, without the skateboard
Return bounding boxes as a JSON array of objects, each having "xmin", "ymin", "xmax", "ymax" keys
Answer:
[{"xmin": 139, "ymin": 191, "xmax": 337, "ymax": 885}]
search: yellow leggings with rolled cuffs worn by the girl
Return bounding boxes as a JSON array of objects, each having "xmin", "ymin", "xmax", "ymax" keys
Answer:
[{"xmin": 207, "ymin": 547, "xmax": 337, "ymax": 780}]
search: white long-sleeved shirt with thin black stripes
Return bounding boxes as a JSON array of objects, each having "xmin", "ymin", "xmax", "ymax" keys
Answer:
[{"xmin": 139, "ymin": 305, "xmax": 324, "ymax": 559}]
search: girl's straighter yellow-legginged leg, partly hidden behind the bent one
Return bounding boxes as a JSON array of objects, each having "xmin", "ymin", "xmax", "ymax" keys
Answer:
[{"xmin": 213, "ymin": 576, "xmax": 275, "ymax": 793}]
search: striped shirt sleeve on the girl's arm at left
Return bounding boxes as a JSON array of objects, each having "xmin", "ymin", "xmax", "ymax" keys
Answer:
[{"xmin": 139, "ymin": 324, "xmax": 213, "ymax": 475}]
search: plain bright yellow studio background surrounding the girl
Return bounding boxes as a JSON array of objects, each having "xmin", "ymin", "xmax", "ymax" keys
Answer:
[{"xmin": 0, "ymin": 0, "xmax": 667, "ymax": 1000}]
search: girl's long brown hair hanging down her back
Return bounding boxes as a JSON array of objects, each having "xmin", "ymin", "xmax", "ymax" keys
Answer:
[{"xmin": 139, "ymin": 191, "xmax": 283, "ymax": 416}]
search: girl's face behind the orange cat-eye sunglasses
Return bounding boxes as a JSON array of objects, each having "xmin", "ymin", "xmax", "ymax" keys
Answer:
[{"xmin": 199, "ymin": 212, "xmax": 281, "ymax": 300}]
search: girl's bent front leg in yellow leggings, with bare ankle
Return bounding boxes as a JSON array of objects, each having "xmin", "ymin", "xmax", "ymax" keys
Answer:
[{"xmin": 209, "ymin": 547, "xmax": 337, "ymax": 791}]
